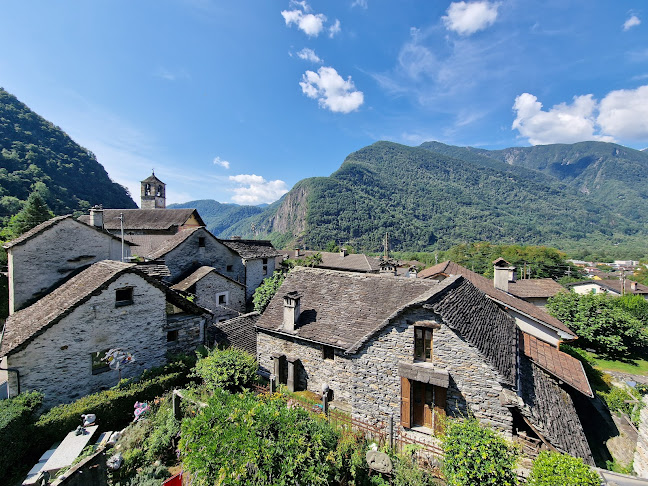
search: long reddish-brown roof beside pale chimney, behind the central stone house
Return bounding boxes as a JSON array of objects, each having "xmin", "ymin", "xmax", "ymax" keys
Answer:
[{"xmin": 418, "ymin": 260, "xmax": 577, "ymax": 339}]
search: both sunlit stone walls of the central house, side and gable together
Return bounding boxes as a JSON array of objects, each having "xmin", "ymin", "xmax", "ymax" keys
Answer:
[{"xmin": 257, "ymin": 310, "xmax": 513, "ymax": 437}]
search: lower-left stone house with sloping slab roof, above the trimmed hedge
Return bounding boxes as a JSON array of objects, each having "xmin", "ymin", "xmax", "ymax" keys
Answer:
[{"xmin": 0, "ymin": 261, "xmax": 209, "ymax": 407}]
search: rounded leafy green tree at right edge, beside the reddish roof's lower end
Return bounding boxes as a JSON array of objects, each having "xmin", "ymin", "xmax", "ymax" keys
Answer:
[{"xmin": 547, "ymin": 292, "xmax": 648, "ymax": 358}]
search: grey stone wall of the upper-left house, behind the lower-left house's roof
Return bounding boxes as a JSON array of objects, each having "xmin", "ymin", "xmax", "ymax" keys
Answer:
[{"xmin": 8, "ymin": 218, "xmax": 130, "ymax": 313}]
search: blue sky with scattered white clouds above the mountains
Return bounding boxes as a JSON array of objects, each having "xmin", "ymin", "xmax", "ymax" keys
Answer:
[{"xmin": 0, "ymin": 0, "xmax": 648, "ymax": 204}]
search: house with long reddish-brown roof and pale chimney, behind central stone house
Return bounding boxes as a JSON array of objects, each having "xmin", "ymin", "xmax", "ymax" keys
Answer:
[{"xmin": 417, "ymin": 260, "xmax": 577, "ymax": 347}]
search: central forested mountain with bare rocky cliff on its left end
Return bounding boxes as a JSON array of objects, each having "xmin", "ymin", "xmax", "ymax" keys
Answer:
[{"xmin": 220, "ymin": 142, "xmax": 645, "ymax": 251}]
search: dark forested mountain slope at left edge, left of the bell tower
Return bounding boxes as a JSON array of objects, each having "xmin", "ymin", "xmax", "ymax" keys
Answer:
[{"xmin": 0, "ymin": 88, "xmax": 137, "ymax": 225}]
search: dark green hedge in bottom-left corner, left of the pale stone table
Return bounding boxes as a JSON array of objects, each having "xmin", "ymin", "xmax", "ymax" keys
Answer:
[{"xmin": 0, "ymin": 392, "xmax": 43, "ymax": 479}]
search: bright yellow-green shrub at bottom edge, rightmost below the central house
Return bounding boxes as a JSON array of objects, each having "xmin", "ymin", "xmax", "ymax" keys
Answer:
[{"xmin": 527, "ymin": 451, "xmax": 601, "ymax": 486}]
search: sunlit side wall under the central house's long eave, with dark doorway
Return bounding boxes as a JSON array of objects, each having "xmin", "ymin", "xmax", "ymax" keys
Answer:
[{"xmin": 257, "ymin": 330, "xmax": 353, "ymax": 408}]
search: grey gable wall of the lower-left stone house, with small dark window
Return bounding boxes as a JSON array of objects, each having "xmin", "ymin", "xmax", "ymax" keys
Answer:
[{"xmin": 7, "ymin": 273, "xmax": 185, "ymax": 407}]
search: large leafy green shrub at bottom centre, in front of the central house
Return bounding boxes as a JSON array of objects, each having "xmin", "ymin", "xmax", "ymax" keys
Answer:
[{"xmin": 179, "ymin": 389, "xmax": 338, "ymax": 486}]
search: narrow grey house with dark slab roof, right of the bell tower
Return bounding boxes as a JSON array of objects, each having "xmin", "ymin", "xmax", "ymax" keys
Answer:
[{"xmin": 216, "ymin": 238, "xmax": 280, "ymax": 304}]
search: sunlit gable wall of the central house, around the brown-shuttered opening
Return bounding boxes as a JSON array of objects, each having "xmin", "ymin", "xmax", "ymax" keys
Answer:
[{"xmin": 352, "ymin": 311, "xmax": 513, "ymax": 436}]
